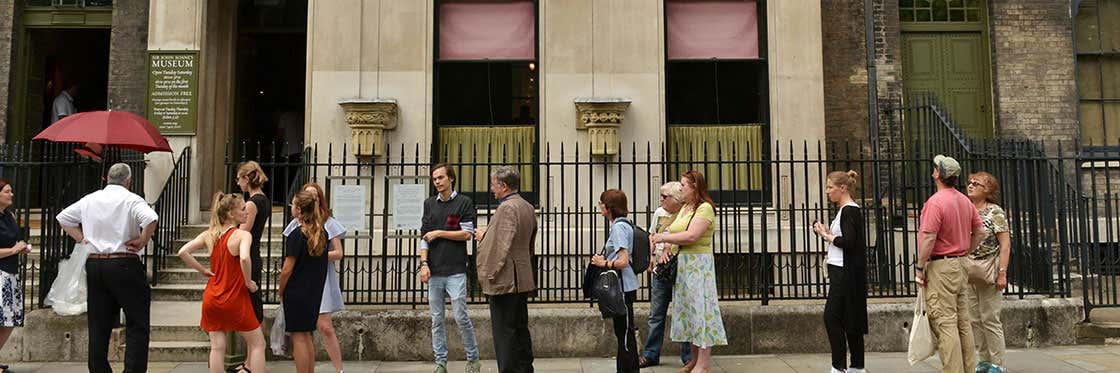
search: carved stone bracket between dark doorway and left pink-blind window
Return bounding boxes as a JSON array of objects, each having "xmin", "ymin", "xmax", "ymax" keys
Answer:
[{"xmin": 338, "ymin": 99, "xmax": 396, "ymax": 157}]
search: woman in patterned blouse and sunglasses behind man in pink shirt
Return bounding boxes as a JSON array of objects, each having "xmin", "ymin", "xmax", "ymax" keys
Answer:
[{"xmin": 968, "ymin": 171, "xmax": 1011, "ymax": 373}]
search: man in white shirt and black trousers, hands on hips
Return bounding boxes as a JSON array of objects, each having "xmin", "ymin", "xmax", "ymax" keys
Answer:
[{"xmin": 56, "ymin": 164, "xmax": 159, "ymax": 373}]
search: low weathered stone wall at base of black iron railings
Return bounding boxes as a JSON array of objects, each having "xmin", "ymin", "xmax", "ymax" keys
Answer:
[{"xmin": 17, "ymin": 298, "xmax": 1084, "ymax": 361}]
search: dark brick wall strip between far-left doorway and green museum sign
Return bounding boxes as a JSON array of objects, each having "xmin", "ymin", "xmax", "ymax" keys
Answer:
[{"xmin": 109, "ymin": 0, "xmax": 149, "ymax": 116}]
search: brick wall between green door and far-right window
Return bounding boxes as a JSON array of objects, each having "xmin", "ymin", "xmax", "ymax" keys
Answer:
[{"xmin": 989, "ymin": 0, "xmax": 1080, "ymax": 153}]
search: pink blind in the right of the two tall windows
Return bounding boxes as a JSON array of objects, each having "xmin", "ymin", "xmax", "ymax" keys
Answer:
[{"xmin": 665, "ymin": 0, "xmax": 758, "ymax": 59}]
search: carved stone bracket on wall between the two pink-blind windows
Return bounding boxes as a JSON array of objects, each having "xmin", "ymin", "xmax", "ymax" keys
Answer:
[{"xmin": 575, "ymin": 97, "xmax": 631, "ymax": 156}]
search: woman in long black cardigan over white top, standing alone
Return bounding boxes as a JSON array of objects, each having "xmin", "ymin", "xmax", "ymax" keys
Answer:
[{"xmin": 813, "ymin": 170, "xmax": 867, "ymax": 373}]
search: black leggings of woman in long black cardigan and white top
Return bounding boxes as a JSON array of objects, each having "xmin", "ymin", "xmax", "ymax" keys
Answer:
[{"xmin": 824, "ymin": 264, "xmax": 864, "ymax": 371}]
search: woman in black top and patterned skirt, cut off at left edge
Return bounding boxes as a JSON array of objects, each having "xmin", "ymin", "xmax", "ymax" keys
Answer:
[{"xmin": 0, "ymin": 179, "xmax": 31, "ymax": 371}]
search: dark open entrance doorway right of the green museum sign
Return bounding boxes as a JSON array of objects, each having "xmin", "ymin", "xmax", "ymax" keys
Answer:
[{"xmin": 230, "ymin": 0, "xmax": 307, "ymax": 197}]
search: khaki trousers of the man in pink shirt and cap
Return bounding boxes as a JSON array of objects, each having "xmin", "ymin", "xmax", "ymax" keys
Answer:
[{"xmin": 925, "ymin": 258, "xmax": 977, "ymax": 373}]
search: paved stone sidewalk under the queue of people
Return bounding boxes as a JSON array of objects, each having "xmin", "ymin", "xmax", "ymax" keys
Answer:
[{"xmin": 10, "ymin": 346, "xmax": 1120, "ymax": 373}]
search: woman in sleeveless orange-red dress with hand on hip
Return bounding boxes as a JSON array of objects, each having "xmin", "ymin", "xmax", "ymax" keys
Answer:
[{"xmin": 179, "ymin": 193, "xmax": 265, "ymax": 373}]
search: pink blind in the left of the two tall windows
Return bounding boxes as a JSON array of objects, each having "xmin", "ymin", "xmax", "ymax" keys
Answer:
[{"xmin": 439, "ymin": 0, "xmax": 536, "ymax": 59}]
